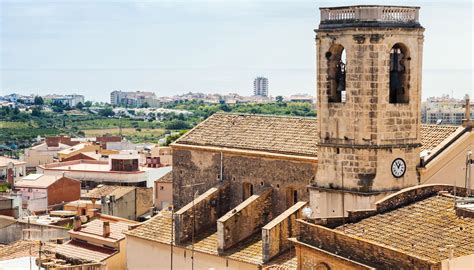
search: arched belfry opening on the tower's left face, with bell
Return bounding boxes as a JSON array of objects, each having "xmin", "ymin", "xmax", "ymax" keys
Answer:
[{"xmin": 326, "ymin": 44, "xmax": 346, "ymax": 102}]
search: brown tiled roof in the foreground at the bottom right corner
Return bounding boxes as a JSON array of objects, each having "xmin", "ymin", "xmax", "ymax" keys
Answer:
[{"xmin": 337, "ymin": 195, "xmax": 474, "ymax": 263}]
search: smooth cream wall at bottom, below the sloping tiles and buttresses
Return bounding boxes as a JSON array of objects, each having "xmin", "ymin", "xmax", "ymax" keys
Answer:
[{"xmin": 126, "ymin": 236, "xmax": 261, "ymax": 270}]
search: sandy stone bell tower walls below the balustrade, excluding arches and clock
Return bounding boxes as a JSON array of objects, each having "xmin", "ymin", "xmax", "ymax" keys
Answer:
[{"xmin": 316, "ymin": 28, "xmax": 424, "ymax": 191}]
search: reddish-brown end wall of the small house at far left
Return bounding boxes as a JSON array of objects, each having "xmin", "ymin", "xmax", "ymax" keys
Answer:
[{"xmin": 48, "ymin": 177, "xmax": 81, "ymax": 205}]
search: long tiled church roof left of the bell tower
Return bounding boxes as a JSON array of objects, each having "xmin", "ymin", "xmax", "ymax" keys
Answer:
[{"xmin": 176, "ymin": 113, "xmax": 317, "ymax": 156}]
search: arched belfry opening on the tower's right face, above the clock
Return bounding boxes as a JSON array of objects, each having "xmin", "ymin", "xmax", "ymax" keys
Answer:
[{"xmin": 389, "ymin": 43, "xmax": 410, "ymax": 103}]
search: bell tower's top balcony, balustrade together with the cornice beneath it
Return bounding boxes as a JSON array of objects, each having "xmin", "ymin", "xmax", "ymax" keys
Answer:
[{"xmin": 319, "ymin": 5, "xmax": 421, "ymax": 29}]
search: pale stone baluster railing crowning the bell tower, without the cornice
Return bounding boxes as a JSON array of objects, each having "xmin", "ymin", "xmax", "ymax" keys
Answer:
[{"xmin": 320, "ymin": 6, "xmax": 419, "ymax": 23}]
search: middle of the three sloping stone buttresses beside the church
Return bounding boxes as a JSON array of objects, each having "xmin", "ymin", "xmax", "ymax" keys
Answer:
[{"xmin": 217, "ymin": 188, "xmax": 272, "ymax": 252}]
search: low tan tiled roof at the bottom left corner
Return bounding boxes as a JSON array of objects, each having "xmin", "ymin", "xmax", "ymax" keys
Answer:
[{"xmin": 0, "ymin": 240, "xmax": 54, "ymax": 261}]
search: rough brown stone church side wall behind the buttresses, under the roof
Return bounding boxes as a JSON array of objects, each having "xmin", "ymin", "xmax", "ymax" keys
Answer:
[{"xmin": 173, "ymin": 149, "xmax": 317, "ymax": 215}]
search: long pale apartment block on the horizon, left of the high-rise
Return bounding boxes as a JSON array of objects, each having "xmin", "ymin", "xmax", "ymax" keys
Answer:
[{"xmin": 110, "ymin": 91, "xmax": 160, "ymax": 107}]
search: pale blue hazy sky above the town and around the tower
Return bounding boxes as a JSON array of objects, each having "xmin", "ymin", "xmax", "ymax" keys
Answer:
[{"xmin": 0, "ymin": 0, "xmax": 474, "ymax": 101}]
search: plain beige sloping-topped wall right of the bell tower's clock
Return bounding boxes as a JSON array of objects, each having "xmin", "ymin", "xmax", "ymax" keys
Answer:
[{"xmin": 420, "ymin": 131, "xmax": 474, "ymax": 187}]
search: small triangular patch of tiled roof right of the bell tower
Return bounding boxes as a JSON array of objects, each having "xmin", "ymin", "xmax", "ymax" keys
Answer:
[{"xmin": 421, "ymin": 124, "xmax": 459, "ymax": 151}]
